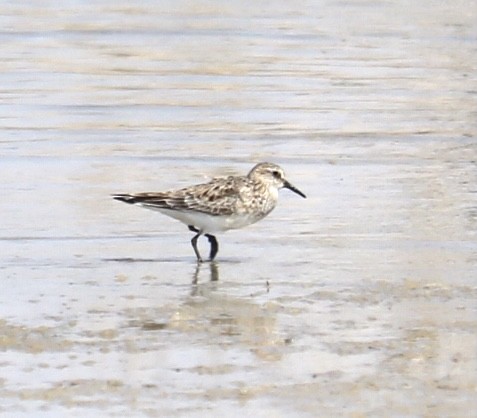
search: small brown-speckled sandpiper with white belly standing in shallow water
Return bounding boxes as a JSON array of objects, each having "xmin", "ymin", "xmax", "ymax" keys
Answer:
[{"xmin": 112, "ymin": 163, "xmax": 306, "ymax": 262}]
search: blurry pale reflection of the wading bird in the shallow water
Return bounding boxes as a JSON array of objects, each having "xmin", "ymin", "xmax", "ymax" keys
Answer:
[{"xmin": 183, "ymin": 262, "xmax": 278, "ymax": 360}]
